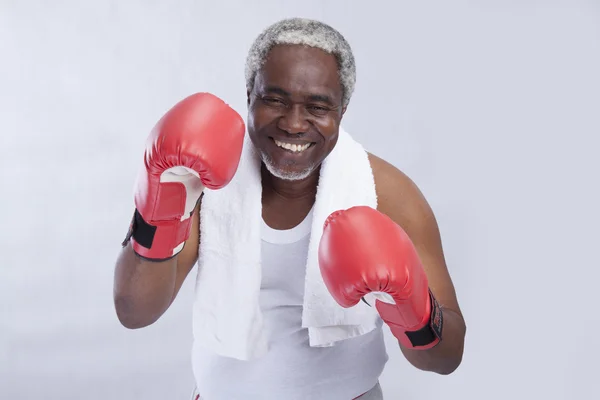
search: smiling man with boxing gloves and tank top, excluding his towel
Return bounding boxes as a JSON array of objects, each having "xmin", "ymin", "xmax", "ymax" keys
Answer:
[{"xmin": 114, "ymin": 19, "xmax": 466, "ymax": 400}]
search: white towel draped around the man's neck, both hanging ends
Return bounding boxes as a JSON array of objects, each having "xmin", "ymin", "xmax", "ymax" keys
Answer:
[{"xmin": 193, "ymin": 128, "xmax": 379, "ymax": 360}]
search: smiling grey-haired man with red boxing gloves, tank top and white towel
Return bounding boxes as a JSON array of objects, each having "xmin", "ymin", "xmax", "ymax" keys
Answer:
[{"xmin": 114, "ymin": 18, "xmax": 466, "ymax": 400}]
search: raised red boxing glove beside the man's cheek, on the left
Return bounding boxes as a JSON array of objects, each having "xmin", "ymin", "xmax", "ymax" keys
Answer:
[{"xmin": 126, "ymin": 93, "xmax": 246, "ymax": 261}]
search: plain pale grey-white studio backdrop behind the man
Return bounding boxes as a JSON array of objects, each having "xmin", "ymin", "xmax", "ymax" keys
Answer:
[{"xmin": 0, "ymin": 0, "xmax": 600, "ymax": 400}]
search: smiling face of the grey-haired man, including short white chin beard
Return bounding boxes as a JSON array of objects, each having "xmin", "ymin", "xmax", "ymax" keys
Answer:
[{"xmin": 248, "ymin": 45, "xmax": 345, "ymax": 180}]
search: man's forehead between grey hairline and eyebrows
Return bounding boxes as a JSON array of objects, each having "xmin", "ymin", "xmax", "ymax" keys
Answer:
[{"xmin": 255, "ymin": 45, "xmax": 342, "ymax": 97}]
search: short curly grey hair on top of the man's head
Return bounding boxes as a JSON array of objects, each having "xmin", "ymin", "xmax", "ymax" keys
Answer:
[{"xmin": 246, "ymin": 18, "xmax": 356, "ymax": 107}]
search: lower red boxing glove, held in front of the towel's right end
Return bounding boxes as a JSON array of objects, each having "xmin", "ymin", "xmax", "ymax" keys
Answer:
[{"xmin": 319, "ymin": 206, "xmax": 442, "ymax": 349}]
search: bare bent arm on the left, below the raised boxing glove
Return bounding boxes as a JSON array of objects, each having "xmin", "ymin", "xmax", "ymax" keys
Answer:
[{"xmin": 113, "ymin": 202, "xmax": 200, "ymax": 329}]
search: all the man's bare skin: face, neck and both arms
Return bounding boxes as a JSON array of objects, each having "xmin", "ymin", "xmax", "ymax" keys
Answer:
[{"xmin": 114, "ymin": 45, "xmax": 466, "ymax": 374}]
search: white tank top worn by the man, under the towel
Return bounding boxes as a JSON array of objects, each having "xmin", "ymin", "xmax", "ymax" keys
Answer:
[{"xmin": 192, "ymin": 210, "xmax": 388, "ymax": 400}]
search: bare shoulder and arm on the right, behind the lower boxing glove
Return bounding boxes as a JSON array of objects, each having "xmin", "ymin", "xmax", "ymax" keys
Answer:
[{"xmin": 369, "ymin": 155, "xmax": 466, "ymax": 374}]
